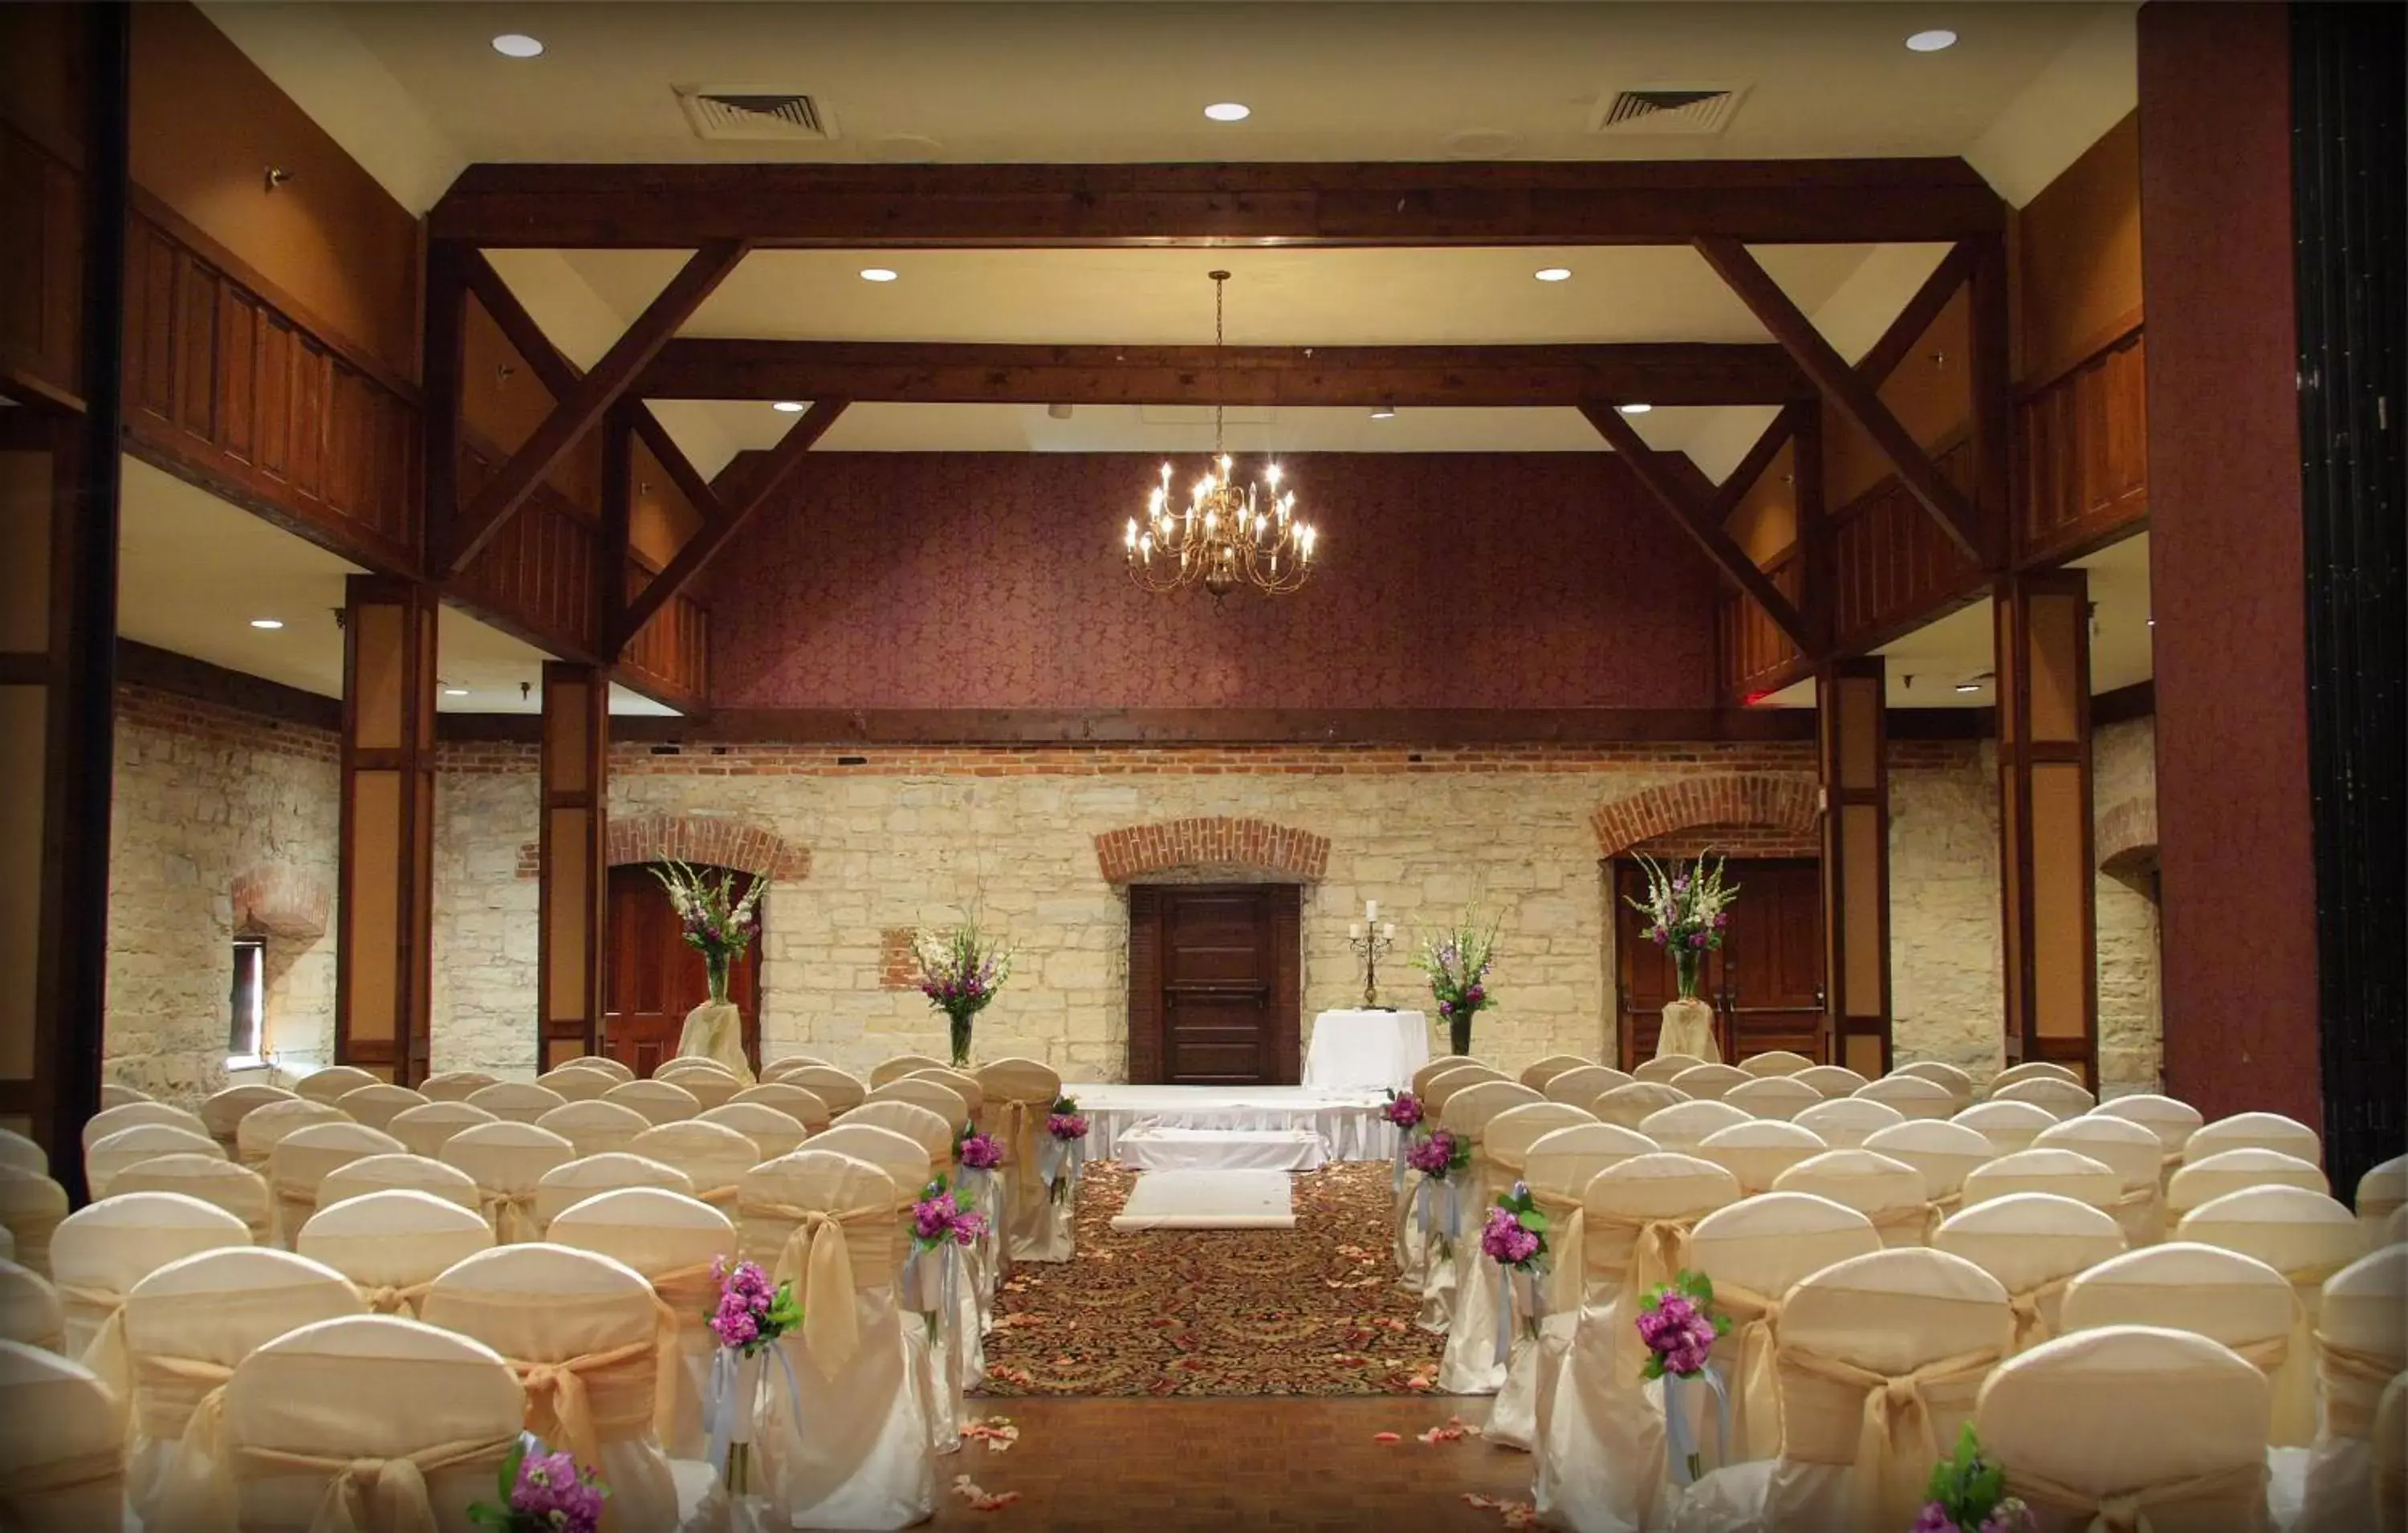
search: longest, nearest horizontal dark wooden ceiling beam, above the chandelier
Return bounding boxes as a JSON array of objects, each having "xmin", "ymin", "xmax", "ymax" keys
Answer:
[{"xmin": 429, "ymin": 159, "xmax": 2006, "ymax": 250}]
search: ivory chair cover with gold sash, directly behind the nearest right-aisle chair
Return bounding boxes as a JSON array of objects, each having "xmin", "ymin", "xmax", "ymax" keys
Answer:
[{"xmin": 1674, "ymin": 1242, "xmax": 2013, "ymax": 1533}]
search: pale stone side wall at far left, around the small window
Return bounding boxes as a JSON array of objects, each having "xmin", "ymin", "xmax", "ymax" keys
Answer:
[{"xmin": 108, "ymin": 686, "xmax": 340, "ymax": 1100}]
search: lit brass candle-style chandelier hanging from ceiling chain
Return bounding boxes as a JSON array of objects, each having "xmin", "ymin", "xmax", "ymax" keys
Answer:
[{"xmin": 1122, "ymin": 272, "xmax": 1317, "ymax": 600}]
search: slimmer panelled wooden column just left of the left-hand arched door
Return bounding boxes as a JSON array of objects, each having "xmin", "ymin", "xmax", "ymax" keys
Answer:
[{"xmin": 535, "ymin": 660, "xmax": 609, "ymax": 1071}]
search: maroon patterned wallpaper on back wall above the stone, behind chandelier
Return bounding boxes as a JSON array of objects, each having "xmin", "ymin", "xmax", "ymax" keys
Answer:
[{"xmin": 710, "ymin": 453, "xmax": 1714, "ymax": 708}]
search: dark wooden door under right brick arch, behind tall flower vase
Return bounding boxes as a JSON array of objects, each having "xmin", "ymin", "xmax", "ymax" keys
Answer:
[{"xmin": 1613, "ymin": 856, "xmax": 1823, "ymax": 1068}]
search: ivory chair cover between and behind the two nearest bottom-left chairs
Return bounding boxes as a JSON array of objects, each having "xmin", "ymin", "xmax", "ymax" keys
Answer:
[{"xmin": 110, "ymin": 1246, "xmax": 366, "ymax": 1533}]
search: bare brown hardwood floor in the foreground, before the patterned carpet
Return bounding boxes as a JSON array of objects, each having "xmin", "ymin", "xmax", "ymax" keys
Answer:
[{"xmin": 932, "ymin": 1396, "xmax": 1531, "ymax": 1533}]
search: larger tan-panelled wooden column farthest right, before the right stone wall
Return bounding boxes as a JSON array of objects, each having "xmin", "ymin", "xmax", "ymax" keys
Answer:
[{"xmin": 1994, "ymin": 571, "xmax": 2100, "ymax": 1088}]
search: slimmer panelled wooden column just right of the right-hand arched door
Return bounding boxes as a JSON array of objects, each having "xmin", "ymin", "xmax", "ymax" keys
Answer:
[{"xmin": 1816, "ymin": 657, "xmax": 1890, "ymax": 1078}]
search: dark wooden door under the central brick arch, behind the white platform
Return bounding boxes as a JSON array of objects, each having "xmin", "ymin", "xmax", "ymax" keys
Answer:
[{"xmin": 1129, "ymin": 883, "xmax": 1303, "ymax": 1085}]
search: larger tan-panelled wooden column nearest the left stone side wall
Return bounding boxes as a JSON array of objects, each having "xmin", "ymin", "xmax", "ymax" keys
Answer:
[{"xmin": 335, "ymin": 575, "xmax": 436, "ymax": 1085}]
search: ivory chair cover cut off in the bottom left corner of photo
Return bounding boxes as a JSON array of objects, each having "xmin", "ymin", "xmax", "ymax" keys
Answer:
[{"xmin": 0, "ymin": 1340, "xmax": 125, "ymax": 1533}]
